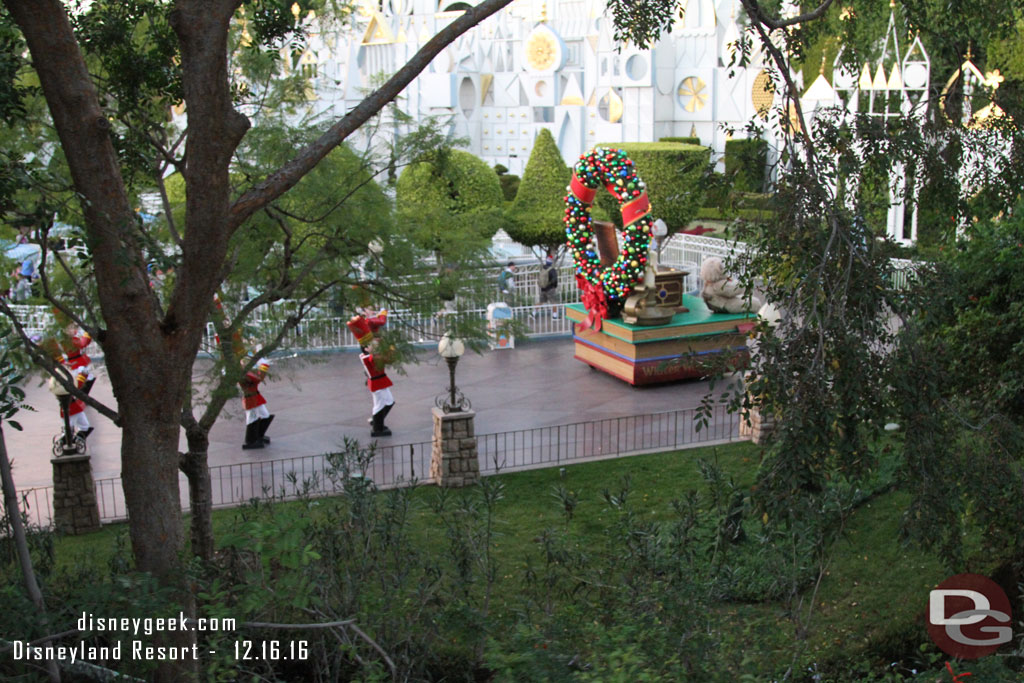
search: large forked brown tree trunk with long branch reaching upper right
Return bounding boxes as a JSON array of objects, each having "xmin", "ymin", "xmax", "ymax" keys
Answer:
[{"xmin": 2, "ymin": 0, "xmax": 524, "ymax": 681}]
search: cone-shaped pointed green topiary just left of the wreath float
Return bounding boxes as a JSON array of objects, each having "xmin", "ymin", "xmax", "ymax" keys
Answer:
[{"xmin": 507, "ymin": 128, "xmax": 572, "ymax": 250}]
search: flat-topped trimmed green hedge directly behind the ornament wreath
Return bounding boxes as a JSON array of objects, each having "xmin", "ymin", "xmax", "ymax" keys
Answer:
[{"xmin": 597, "ymin": 142, "xmax": 711, "ymax": 232}]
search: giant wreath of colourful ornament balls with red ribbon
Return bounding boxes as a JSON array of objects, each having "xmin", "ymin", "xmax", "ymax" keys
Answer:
[{"xmin": 564, "ymin": 147, "xmax": 651, "ymax": 330}]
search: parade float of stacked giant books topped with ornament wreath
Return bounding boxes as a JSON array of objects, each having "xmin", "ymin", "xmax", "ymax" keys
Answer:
[{"xmin": 564, "ymin": 147, "xmax": 757, "ymax": 386}]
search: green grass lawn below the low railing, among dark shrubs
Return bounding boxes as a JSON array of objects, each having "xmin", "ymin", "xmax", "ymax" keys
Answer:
[{"xmin": 32, "ymin": 442, "xmax": 966, "ymax": 680}]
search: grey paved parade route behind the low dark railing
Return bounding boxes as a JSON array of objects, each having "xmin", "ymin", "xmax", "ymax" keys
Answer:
[{"xmin": 4, "ymin": 337, "xmax": 729, "ymax": 489}]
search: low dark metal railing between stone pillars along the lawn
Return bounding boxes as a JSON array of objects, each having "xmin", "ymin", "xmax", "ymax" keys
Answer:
[{"xmin": 19, "ymin": 405, "xmax": 740, "ymax": 526}]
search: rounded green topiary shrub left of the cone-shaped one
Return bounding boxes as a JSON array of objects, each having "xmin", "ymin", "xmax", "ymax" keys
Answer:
[{"xmin": 395, "ymin": 150, "xmax": 504, "ymax": 251}]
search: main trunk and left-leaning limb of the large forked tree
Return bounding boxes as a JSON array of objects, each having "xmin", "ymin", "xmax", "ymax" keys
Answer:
[{"xmin": 3, "ymin": 14, "xmax": 199, "ymax": 682}]
